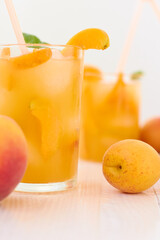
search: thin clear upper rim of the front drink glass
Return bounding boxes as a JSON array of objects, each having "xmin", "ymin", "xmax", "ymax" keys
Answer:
[{"xmin": 0, "ymin": 43, "xmax": 84, "ymax": 51}]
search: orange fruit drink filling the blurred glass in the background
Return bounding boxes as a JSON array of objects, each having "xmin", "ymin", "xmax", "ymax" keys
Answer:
[{"xmin": 80, "ymin": 74, "xmax": 139, "ymax": 162}]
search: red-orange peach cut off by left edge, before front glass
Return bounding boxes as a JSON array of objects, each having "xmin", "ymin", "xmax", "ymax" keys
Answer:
[{"xmin": 0, "ymin": 115, "xmax": 27, "ymax": 200}]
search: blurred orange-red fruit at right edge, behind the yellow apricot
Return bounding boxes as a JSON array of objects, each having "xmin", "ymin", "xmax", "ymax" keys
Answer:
[{"xmin": 140, "ymin": 117, "xmax": 160, "ymax": 152}]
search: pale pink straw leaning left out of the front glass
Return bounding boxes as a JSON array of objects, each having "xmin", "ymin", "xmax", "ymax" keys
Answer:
[{"xmin": 5, "ymin": 0, "xmax": 28, "ymax": 54}]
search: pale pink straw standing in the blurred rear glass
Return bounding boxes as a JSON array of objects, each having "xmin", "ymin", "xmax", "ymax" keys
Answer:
[{"xmin": 117, "ymin": 0, "xmax": 145, "ymax": 72}]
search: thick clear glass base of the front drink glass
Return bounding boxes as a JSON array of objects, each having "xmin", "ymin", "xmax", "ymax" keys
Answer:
[{"xmin": 15, "ymin": 178, "xmax": 77, "ymax": 193}]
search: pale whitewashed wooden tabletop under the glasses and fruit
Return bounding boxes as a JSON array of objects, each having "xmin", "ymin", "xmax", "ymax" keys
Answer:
[{"xmin": 0, "ymin": 161, "xmax": 160, "ymax": 240}]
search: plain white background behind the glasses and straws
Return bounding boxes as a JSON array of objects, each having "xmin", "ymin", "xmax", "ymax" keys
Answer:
[{"xmin": 0, "ymin": 0, "xmax": 160, "ymax": 121}]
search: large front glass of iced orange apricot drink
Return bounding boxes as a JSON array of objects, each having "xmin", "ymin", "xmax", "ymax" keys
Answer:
[{"xmin": 0, "ymin": 45, "xmax": 83, "ymax": 192}]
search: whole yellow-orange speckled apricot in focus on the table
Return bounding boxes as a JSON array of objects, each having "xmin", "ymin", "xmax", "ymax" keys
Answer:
[{"xmin": 103, "ymin": 139, "xmax": 160, "ymax": 193}]
